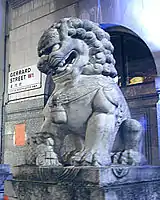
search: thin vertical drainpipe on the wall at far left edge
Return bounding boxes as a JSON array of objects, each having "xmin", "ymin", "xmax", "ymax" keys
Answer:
[{"xmin": 0, "ymin": 0, "xmax": 8, "ymax": 163}]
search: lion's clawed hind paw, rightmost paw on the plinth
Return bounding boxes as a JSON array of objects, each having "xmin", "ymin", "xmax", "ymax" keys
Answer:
[{"xmin": 112, "ymin": 149, "xmax": 146, "ymax": 165}]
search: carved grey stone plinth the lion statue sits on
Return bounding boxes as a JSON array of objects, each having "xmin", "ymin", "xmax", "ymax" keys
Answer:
[{"xmin": 4, "ymin": 166, "xmax": 160, "ymax": 200}]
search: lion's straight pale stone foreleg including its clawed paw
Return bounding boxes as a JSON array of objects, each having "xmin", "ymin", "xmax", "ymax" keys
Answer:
[{"xmin": 72, "ymin": 112, "xmax": 115, "ymax": 166}]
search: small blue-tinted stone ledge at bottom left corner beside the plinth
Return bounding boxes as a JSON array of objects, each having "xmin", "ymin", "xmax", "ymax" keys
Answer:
[{"xmin": 0, "ymin": 164, "xmax": 12, "ymax": 200}]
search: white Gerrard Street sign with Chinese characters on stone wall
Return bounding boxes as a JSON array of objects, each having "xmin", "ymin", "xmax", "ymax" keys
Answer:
[{"xmin": 8, "ymin": 65, "xmax": 41, "ymax": 94}]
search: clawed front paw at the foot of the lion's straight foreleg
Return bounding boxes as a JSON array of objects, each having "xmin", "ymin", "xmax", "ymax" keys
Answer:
[{"xmin": 71, "ymin": 149, "xmax": 111, "ymax": 167}]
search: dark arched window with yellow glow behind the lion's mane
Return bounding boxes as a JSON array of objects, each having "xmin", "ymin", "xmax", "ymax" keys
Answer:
[{"xmin": 106, "ymin": 26, "xmax": 156, "ymax": 87}]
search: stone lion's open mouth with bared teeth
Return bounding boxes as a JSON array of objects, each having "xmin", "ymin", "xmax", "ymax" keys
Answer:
[{"xmin": 56, "ymin": 50, "xmax": 77, "ymax": 74}]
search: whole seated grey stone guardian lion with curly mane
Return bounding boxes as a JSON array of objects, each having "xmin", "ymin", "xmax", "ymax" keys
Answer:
[{"xmin": 26, "ymin": 18, "xmax": 144, "ymax": 166}]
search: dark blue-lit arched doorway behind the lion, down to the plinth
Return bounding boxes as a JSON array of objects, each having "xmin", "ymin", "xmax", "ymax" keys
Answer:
[{"xmin": 100, "ymin": 24, "xmax": 160, "ymax": 165}]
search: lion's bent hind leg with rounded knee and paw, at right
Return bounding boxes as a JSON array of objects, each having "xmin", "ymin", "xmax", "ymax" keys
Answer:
[{"xmin": 112, "ymin": 119, "xmax": 146, "ymax": 165}]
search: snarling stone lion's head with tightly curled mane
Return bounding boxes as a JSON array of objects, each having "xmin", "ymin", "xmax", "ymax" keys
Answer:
[{"xmin": 38, "ymin": 18, "xmax": 117, "ymax": 78}]
